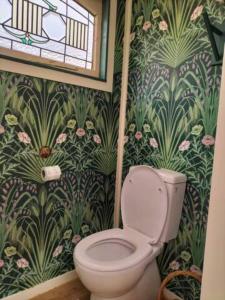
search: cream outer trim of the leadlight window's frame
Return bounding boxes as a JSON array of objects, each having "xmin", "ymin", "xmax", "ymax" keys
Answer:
[{"xmin": 0, "ymin": 0, "xmax": 117, "ymax": 92}]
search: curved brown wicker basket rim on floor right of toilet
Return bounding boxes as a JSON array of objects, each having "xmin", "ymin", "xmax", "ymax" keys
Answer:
[{"xmin": 157, "ymin": 271, "xmax": 202, "ymax": 300}]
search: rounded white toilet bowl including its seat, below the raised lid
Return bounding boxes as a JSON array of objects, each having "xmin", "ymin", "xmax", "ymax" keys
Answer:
[{"xmin": 74, "ymin": 229, "xmax": 160, "ymax": 300}]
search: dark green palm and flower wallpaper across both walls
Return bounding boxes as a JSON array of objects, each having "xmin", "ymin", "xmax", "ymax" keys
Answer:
[{"xmin": 0, "ymin": 0, "xmax": 225, "ymax": 300}]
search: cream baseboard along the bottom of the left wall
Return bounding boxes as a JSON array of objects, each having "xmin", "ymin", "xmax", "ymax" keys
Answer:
[{"xmin": 2, "ymin": 270, "xmax": 77, "ymax": 300}]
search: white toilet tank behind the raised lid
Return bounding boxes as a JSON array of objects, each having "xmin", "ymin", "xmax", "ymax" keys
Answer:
[{"xmin": 156, "ymin": 169, "xmax": 187, "ymax": 243}]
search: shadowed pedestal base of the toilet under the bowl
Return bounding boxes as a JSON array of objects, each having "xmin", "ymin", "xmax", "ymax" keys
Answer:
[{"xmin": 90, "ymin": 259, "xmax": 161, "ymax": 300}]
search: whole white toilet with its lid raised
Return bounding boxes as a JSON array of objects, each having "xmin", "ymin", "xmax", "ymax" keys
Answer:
[{"xmin": 73, "ymin": 166, "xmax": 186, "ymax": 300}]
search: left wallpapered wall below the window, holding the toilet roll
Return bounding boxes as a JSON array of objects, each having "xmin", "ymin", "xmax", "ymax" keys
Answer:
[{"xmin": 0, "ymin": 72, "xmax": 119, "ymax": 298}]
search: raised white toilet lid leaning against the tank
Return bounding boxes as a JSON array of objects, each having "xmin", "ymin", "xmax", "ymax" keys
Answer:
[{"xmin": 121, "ymin": 166, "xmax": 168, "ymax": 243}]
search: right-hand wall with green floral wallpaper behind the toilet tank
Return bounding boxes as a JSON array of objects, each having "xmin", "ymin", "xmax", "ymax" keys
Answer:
[{"xmin": 121, "ymin": 0, "xmax": 225, "ymax": 299}]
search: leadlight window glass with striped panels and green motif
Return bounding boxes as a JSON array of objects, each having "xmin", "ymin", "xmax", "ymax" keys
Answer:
[{"xmin": 0, "ymin": 0, "xmax": 95, "ymax": 70}]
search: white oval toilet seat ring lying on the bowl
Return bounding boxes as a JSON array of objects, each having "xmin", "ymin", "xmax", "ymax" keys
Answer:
[{"xmin": 74, "ymin": 229, "xmax": 153, "ymax": 272}]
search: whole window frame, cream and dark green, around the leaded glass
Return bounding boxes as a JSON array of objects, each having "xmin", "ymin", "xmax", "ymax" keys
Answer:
[{"xmin": 0, "ymin": 0, "xmax": 117, "ymax": 92}]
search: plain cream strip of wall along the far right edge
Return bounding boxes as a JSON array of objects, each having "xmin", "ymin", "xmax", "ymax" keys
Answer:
[{"xmin": 201, "ymin": 47, "xmax": 225, "ymax": 300}]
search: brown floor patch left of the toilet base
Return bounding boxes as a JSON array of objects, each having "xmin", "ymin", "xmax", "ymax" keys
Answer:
[{"xmin": 30, "ymin": 279, "xmax": 90, "ymax": 300}]
